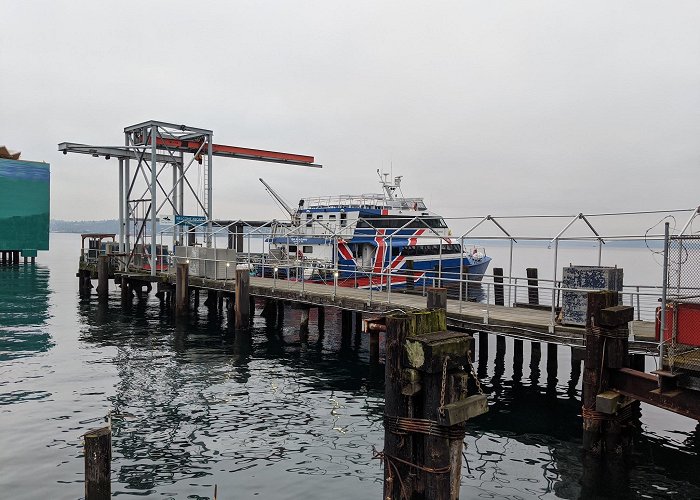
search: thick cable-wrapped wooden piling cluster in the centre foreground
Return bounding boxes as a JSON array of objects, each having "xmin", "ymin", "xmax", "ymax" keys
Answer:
[{"xmin": 383, "ymin": 309, "xmax": 488, "ymax": 500}]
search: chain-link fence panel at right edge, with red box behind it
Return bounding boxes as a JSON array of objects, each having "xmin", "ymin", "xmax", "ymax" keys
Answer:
[{"xmin": 657, "ymin": 236, "xmax": 700, "ymax": 372}]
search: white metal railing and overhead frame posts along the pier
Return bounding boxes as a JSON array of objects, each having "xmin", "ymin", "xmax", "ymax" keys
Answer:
[{"xmin": 94, "ymin": 202, "xmax": 700, "ymax": 350}]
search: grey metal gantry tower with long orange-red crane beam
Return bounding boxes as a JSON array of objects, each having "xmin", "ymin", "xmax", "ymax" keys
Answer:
[{"xmin": 58, "ymin": 120, "xmax": 321, "ymax": 276}]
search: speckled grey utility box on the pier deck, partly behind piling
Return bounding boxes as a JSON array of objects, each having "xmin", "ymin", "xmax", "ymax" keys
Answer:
[{"xmin": 561, "ymin": 266, "xmax": 623, "ymax": 326}]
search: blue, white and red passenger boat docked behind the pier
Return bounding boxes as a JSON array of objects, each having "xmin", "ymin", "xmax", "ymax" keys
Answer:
[{"xmin": 260, "ymin": 170, "xmax": 491, "ymax": 289}]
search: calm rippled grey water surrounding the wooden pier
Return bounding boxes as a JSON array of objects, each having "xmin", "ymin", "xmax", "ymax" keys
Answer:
[{"xmin": 0, "ymin": 234, "xmax": 700, "ymax": 499}]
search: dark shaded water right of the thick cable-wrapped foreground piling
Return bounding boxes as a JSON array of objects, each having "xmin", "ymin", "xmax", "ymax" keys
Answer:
[{"xmin": 463, "ymin": 335, "xmax": 700, "ymax": 500}]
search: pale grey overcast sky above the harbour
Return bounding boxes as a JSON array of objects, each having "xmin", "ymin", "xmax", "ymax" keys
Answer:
[{"xmin": 0, "ymin": 0, "xmax": 700, "ymax": 235}]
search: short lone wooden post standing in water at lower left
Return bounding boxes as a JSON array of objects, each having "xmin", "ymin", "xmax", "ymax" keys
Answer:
[{"xmin": 83, "ymin": 426, "xmax": 112, "ymax": 500}]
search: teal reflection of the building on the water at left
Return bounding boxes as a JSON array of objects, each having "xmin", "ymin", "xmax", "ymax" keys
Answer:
[{"xmin": 0, "ymin": 265, "xmax": 54, "ymax": 362}]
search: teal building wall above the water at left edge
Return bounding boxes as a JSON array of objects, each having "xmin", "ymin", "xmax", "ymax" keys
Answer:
[{"xmin": 0, "ymin": 158, "xmax": 50, "ymax": 257}]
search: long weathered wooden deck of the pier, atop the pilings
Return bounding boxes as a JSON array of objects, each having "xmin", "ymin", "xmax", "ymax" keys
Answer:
[{"xmin": 116, "ymin": 272, "xmax": 657, "ymax": 354}]
